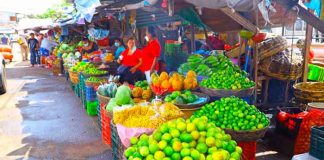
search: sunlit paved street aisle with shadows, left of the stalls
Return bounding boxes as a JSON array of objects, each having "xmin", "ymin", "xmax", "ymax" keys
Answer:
[{"xmin": 0, "ymin": 63, "xmax": 112, "ymax": 160}]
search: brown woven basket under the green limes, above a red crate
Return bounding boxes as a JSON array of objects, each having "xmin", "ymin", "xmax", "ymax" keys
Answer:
[{"xmin": 224, "ymin": 126, "xmax": 269, "ymax": 142}]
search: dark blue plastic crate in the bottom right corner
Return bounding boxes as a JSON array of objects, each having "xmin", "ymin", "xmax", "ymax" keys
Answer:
[{"xmin": 309, "ymin": 126, "xmax": 324, "ymax": 160}]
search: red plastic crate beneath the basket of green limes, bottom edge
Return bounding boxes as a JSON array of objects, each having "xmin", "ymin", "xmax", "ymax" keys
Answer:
[{"xmin": 237, "ymin": 141, "xmax": 256, "ymax": 160}]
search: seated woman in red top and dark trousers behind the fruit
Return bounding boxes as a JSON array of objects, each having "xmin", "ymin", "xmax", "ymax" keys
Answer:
[{"xmin": 117, "ymin": 37, "xmax": 143, "ymax": 84}]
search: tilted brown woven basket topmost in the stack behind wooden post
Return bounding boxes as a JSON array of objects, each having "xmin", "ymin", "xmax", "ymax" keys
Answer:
[{"xmin": 258, "ymin": 36, "xmax": 288, "ymax": 60}]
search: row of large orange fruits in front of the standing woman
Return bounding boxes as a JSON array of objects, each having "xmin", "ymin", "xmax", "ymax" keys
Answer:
[{"xmin": 151, "ymin": 71, "xmax": 198, "ymax": 91}]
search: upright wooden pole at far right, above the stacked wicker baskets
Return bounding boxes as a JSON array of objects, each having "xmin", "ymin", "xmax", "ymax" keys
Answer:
[{"xmin": 303, "ymin": 10, "xmax": 314, "ymax": 82}]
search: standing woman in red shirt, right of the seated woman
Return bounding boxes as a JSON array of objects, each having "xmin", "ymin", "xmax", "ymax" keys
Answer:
[{"xmin": 141, "ymin": 27, "xmax": 161, "ymax": 83}]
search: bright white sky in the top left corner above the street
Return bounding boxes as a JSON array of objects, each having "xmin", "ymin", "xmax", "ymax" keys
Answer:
[{"xmin": 0, "ymin": 0, "xmax": 62, "ymax": 14}]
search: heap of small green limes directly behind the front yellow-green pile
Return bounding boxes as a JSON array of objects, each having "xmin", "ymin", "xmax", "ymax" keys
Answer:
[{"xmin": 191, "ymin": 97, "xmax": 270, "ymax": 131}]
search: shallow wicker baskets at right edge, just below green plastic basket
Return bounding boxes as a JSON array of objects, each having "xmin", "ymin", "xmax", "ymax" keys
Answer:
[{"xmin": 294, "ymin": 82, "xmax": 324, "ymax": 102}]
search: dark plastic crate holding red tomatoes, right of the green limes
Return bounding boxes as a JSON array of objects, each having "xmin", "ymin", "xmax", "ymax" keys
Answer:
[{"xmin": 275, "ymin": 107, "xmax": 303, "ymax": 138}]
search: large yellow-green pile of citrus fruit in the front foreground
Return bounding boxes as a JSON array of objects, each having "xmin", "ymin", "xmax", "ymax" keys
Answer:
[{"xmin": 124, "ymin": 117, "xmax": 242, "ymax": 160}]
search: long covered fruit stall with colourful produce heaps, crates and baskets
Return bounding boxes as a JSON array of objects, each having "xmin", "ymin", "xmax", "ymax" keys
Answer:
[{"xmin": 32, "ymin": 0, "xmax": 324, "ymax": 160}]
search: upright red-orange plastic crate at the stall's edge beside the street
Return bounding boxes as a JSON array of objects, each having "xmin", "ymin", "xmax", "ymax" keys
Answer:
[{"xmin": 100, "ymin": 105, "xmax": 111, "ymax": 146}]
